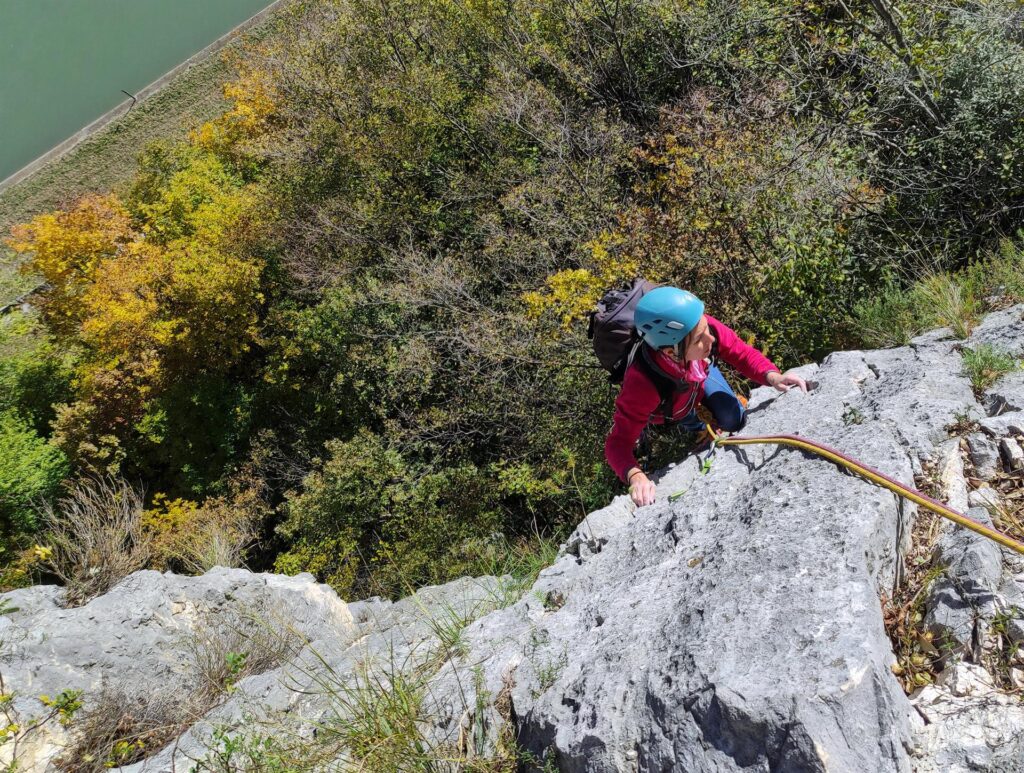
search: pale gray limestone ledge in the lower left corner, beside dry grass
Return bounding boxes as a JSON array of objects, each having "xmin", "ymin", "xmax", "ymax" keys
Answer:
[{"xmin": 0, "ymin": 567, "xmax": 357, "ymax": 770}]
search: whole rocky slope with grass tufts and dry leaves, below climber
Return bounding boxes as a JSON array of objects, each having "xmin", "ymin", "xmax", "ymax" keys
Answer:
[{"xmin": 2, "ymin": 306, "xmax": 1024, "ymax": 773}]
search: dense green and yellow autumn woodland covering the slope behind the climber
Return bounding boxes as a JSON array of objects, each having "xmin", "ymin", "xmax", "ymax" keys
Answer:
[{"xmin": 0, "ymin": 0, "xmax": 1024, "ymax": 597}]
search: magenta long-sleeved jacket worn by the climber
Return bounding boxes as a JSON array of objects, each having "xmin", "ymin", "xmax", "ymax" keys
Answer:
[{"xmin": 604, "ymin": 314, "xmax": 778, "ymax": 482}]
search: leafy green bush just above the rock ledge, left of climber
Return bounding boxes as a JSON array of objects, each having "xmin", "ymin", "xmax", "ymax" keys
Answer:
[{"xmin": 276, "ymin": 432, "xmax": 499, "ymax": 598}]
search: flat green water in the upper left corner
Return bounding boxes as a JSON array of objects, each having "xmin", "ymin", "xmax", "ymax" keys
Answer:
[{"xmin": 0, "ymin": 0, "xmax": 270, "ymax": 180}]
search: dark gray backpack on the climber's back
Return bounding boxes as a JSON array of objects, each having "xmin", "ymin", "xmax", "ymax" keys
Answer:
[{"xmin": 587, "ymin": 278, "xmax": 681, "ymax": 421}]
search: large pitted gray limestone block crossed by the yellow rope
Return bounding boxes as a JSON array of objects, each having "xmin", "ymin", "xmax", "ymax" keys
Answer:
[{"xmin": 421, "ymin": 340, "xmax": 978, "ymax": 771}]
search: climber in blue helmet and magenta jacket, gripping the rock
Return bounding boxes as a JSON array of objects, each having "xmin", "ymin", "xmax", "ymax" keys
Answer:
[{"xmin": 604, "ymin": 287, "xmax": 807, "ymax": 507}]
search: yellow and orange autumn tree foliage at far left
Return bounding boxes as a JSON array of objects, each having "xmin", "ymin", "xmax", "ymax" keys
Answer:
[{"xmin": 10, "ymin": 147, "xmax": 266, "ymax": 471}]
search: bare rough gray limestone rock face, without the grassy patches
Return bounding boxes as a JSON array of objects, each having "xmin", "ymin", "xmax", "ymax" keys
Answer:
[{"xmin": 6, "ymin": 307, "xmax": 1024, "ymax": 773}]
